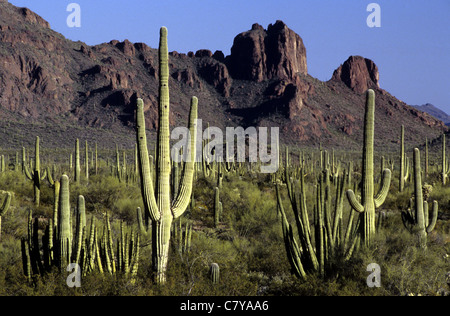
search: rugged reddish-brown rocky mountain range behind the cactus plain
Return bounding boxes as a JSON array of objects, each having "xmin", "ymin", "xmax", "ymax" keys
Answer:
[{"xmin": 0, "ymin": 1, "xmax": 446, "ymax": 150}]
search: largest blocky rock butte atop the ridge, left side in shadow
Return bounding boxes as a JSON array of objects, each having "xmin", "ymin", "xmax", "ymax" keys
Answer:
[{"xmin": 225, "ymin": 21, "xmax": 308, "ymax": 82}]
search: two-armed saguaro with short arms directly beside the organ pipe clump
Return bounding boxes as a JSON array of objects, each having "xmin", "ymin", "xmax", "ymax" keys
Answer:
[{"xmin": 347, "ymin": 89, "xmax": 391, "ymax": 246}]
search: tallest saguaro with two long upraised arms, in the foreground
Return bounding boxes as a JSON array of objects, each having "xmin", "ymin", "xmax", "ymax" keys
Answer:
[{"xmin": 136, "ymin": 27, "xmax": 198, "ymax": 284}]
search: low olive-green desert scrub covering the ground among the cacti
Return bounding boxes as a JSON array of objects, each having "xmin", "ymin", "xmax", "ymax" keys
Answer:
[{"xmin": 0, "ymin": 152, "xmax": 450, "ymax": 296}]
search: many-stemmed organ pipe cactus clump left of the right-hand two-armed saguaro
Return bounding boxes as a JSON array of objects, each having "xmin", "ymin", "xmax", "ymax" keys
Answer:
[{"xmin": 276, "ymin": 165, "xmax": 356, "ymax": 279}]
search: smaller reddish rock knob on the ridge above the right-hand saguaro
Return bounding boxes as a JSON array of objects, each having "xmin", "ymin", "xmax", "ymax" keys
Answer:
[{"xmin": 331, "ymin": 56, "xmax": 380, "ymax": 93}]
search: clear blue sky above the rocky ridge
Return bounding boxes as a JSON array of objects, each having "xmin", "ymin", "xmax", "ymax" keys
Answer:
[{"xmin": 9, "ymin": 0, "xmax": 450, "ymax": 114}]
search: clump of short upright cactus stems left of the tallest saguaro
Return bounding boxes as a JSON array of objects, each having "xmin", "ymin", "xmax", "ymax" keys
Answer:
[{"xmin": 22, "ymin": 174, "xmax": 139, "ymax": 281}]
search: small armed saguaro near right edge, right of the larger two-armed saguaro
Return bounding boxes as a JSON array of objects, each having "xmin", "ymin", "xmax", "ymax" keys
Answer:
[{"xmin": 402, "ymin": 148, "xmax": 438, "ymax": 249}]
